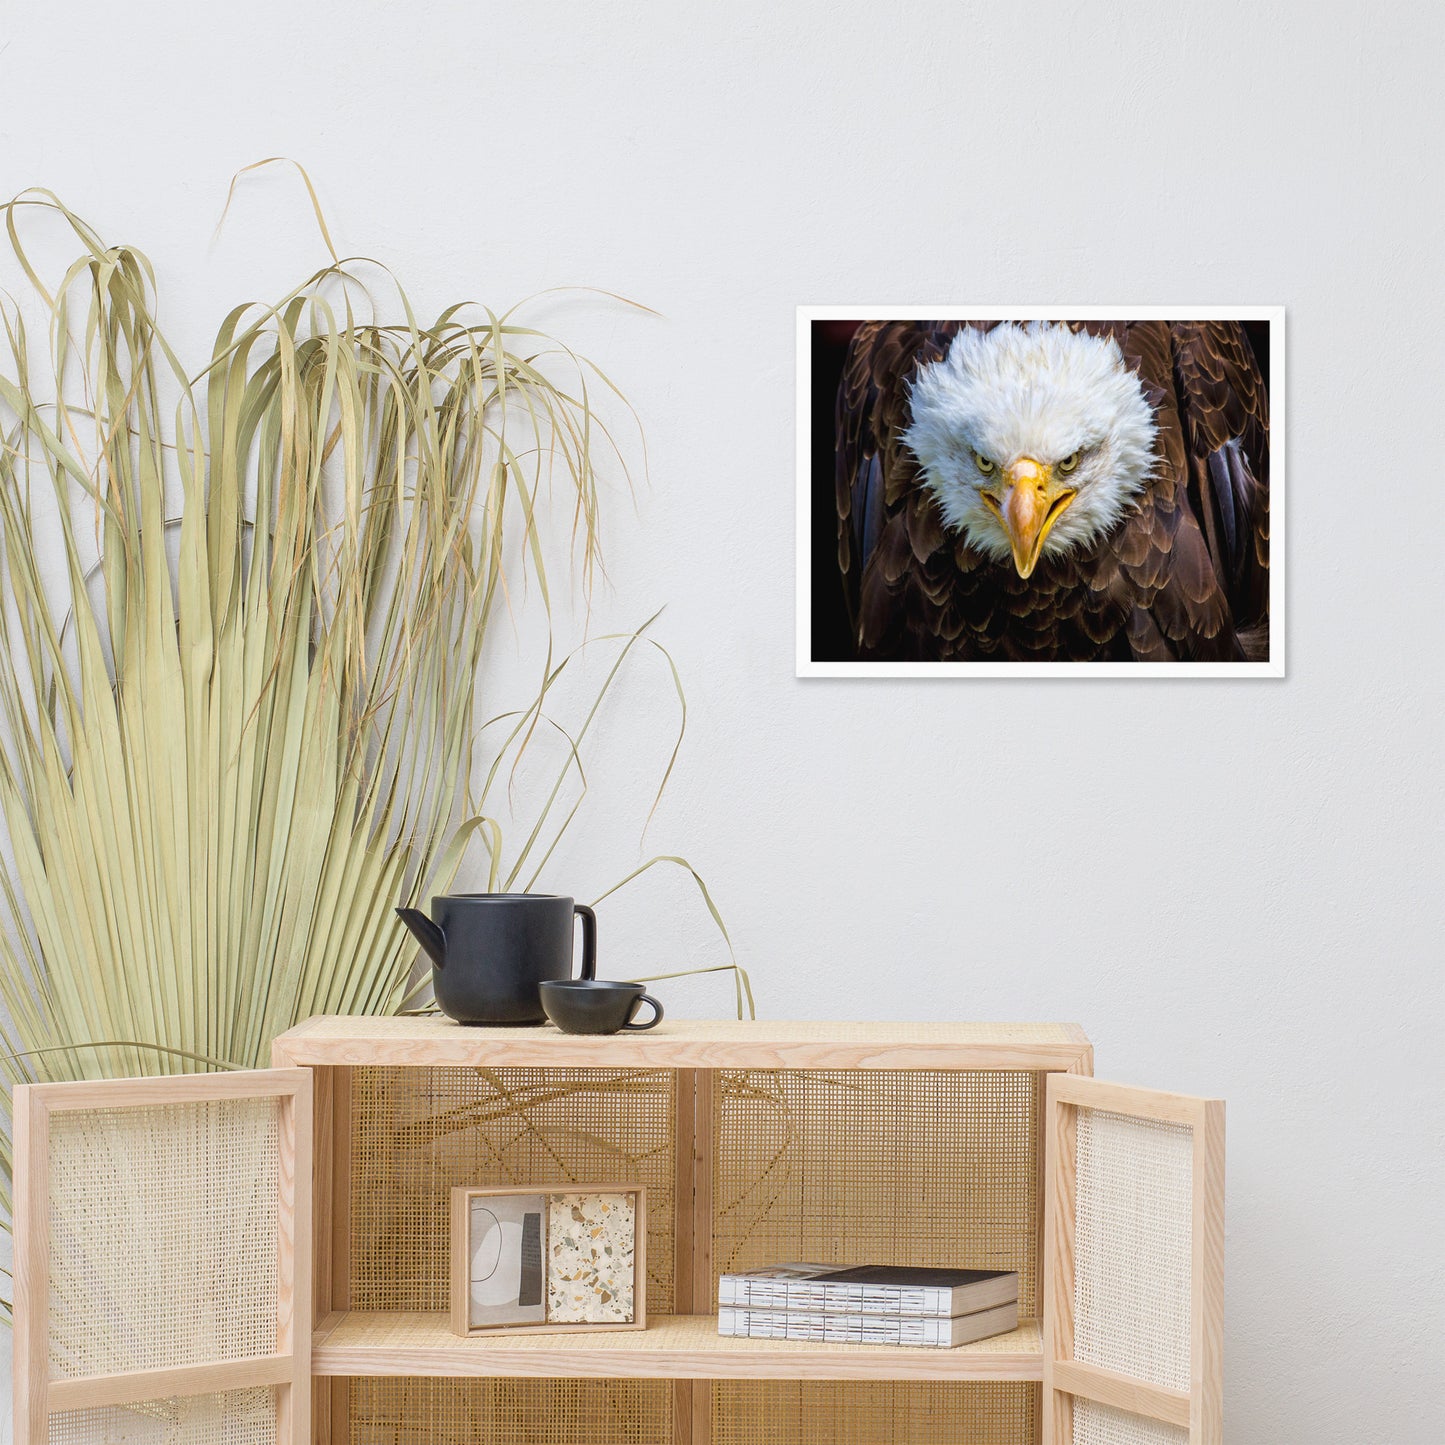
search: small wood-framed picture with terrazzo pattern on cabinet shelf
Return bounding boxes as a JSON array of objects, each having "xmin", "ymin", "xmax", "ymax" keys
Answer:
[{"xmin": 451, "ymin": 1183, "xmax": 647, "ymax": 1335}]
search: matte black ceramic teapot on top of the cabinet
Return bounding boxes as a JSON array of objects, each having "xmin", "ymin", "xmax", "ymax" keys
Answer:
[{"xmin": 396, "ymin": 893, "xmax": 597, "ymax": 1025}]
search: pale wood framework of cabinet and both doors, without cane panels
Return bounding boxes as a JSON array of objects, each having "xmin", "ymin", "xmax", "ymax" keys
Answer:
[{"xmin": 5, "ymin": 1017, "xmax": 1224, "ymax": 1445}]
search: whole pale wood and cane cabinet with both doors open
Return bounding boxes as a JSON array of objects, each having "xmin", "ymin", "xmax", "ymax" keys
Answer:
[{"xmin": 16, "ymin": 1019, "xmax": 1222, "ymax": 1445}]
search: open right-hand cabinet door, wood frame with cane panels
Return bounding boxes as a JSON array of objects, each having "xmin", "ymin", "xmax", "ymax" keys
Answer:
[{"xmin": 1043, "ymin": 1074, "xmax": 1224, "ymax": 1445}]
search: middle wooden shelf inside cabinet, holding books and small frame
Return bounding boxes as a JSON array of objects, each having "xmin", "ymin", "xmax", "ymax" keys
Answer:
[{"xmin": 311, "ymin": 1311, "xmax": 1043, "ymax": 1380}]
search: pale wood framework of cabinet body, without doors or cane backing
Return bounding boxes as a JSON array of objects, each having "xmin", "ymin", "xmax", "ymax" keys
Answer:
[{"xmin": 272, "ymin": 1017, "xmax": 1094, "ymax": 1445}]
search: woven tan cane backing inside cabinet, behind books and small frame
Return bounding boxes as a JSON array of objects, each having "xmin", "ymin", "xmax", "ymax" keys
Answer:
[{"xmin": 347, "ymin": 1068, "xmax": 1042, "ymax": 1445}]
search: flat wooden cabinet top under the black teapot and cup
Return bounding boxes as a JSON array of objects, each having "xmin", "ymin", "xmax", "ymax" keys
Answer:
[{"xmin": 272, "ymin": 1016, "xmax": 1094, "ymax": 1074}]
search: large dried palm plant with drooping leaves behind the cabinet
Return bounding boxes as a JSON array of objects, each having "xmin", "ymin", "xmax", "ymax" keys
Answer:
[{"xmin": 0, "ymin": 171, "xmax": 750, "ymax": 1323}]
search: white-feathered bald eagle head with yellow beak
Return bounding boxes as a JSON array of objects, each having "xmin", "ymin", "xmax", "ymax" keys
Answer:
[{"xmin": 903, "ymin": 321, "xmax": 1155, "ymax": 577}]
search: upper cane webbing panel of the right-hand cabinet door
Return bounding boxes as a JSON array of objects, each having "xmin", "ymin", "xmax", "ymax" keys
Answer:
[{"xmin": 1074, "ymin": 1108, "xmax": 1194, "ymax": 1387}]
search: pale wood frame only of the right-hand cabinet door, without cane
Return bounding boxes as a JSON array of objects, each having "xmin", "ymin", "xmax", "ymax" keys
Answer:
[{"xmin": 1043, "ymin": 1074, "xmax": 1224, "ymax": 1445}]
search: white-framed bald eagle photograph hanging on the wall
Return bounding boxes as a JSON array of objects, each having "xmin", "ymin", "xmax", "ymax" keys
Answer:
[{"xmin": 798, "ymin": 306, "xmax": 1285, "ymax": 676}]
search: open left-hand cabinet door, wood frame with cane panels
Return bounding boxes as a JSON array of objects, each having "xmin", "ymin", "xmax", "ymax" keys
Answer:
[{"xmin": 14, "ymin": 1069, "xmax": 311, "ymax": 1445}]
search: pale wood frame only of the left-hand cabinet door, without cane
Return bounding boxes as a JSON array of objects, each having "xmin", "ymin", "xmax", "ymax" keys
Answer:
[{"xmin": 14, "ymin": 1068, "xmax": 314, "ymax": 1445}]
